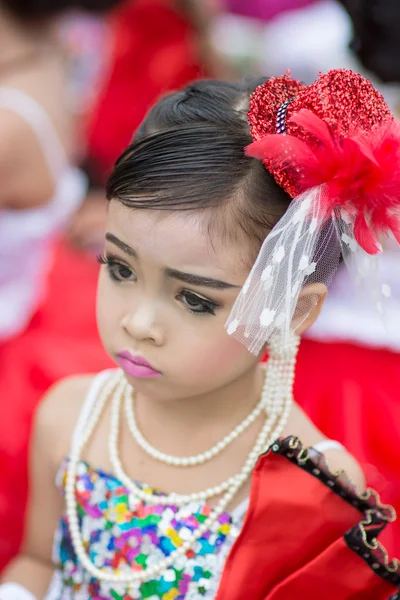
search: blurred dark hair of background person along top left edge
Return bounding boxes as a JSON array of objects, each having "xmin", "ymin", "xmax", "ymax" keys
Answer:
[{"xmin": 1, "ymin": 0, "xmax": 121, "ymax": 21}]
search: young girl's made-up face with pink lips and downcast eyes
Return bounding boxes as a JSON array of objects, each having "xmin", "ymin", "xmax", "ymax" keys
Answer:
[{"xmin": 97, "ymin": 200, "xmax": 258, "ymax": 400}]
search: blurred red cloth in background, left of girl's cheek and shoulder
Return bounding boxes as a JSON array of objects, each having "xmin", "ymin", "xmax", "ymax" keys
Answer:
[{"xmin": 0, "ymin": 239, "xmax": 112, "ymax": 570}]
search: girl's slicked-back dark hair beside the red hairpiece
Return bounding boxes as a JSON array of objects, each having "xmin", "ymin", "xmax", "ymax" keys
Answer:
[{"xmin": 107, "ymin": 79, "xmax": 290, "ymax": 264}]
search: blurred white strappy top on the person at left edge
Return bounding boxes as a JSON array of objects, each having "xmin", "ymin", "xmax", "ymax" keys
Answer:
[{"xmin": 0, "ymin": 87, "xmax": 87, "ymax": 342}]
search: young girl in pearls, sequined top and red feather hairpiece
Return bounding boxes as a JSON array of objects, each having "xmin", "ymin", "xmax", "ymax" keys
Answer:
[{"xmin": 0, "ymin": 71, "xmax": 400, "ymax": 600}]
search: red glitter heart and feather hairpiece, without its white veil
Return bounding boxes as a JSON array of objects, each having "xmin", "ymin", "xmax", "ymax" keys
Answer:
[{"xmin": 246, "ymin": 70, "xmax": 400, "ymax": 254}]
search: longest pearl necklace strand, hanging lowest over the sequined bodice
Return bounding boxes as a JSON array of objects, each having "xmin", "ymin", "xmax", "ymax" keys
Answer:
[{"xmin": 65, "ymin": 332, "xmax": 295, "ymax": 584}]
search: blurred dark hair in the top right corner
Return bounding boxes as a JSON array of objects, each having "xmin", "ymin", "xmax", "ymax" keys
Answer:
[{"xmin": 340, "ymin": 0, "xmax": 400, "ymax": 82}]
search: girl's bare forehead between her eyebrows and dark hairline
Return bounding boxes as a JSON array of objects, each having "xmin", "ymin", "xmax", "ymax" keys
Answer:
[{"xmin": 107, "ymin": 200, "xmax": 250, "ymax": 276}]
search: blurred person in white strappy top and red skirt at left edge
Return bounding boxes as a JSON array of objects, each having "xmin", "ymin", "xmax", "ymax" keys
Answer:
[{"xmin": 0, "ymin": 0, "xmax": 123, "ymax": 563}]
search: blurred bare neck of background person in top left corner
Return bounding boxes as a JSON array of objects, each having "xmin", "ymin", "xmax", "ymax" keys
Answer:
[{"xmin": 0, "ymin": 7, "xmax": 54, "ymax": 77}]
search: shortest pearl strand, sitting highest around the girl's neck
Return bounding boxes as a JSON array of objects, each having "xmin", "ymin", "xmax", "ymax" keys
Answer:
[{"xmin": 125, "ymin": 376, "xmax": 268, "ymax": 468}]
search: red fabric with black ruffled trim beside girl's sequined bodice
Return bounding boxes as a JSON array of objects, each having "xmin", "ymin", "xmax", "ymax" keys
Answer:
[{"xmin": 216, "ymin": 452, "xmax": 396, "ymax": 600}]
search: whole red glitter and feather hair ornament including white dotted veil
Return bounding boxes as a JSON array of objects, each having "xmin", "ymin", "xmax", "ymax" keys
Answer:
[{"xmin": 227, "ymin": 69, "xmax": 400, "ymax": 353}]
